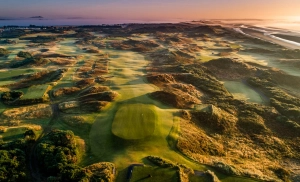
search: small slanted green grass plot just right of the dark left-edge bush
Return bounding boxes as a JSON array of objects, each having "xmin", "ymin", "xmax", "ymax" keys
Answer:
[{"xmin": 21, "ymin": 85, "xmax": 50, "ymax": 100}]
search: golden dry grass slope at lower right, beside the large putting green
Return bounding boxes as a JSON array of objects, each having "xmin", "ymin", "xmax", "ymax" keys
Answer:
[{"xmin": 177, "ymin": 115, "xmax": 291, "ymax": 180}]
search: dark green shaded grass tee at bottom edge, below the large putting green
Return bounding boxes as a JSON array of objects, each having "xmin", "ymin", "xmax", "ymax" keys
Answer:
[{"xmin": 130, "ymin": 166, "xmax": 179, "ymax": 182}]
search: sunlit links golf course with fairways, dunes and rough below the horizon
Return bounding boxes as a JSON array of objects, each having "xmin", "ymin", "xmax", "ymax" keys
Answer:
[{"xmin": 0, "ymin": 22, "xmax": 300, "ymax": 182}]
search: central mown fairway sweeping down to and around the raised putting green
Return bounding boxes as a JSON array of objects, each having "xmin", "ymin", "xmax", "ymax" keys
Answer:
[{"xmin": 88, "ymin": 49, "xmax": 205, "ymax": 172}]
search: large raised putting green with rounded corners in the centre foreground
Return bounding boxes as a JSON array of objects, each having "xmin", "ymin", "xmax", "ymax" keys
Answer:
[{"xmin": 112, "ymin": 104, "xmax": 158, "ymax": 140}]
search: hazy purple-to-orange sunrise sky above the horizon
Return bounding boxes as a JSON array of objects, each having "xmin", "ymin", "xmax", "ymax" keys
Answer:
[{"xmin": 0, "ymin": 0, "xmax": 300, "ymax": 20}]
